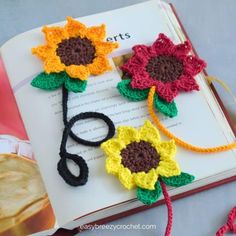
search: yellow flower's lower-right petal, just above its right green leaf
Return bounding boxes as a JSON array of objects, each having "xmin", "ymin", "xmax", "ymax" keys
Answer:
[{"xmin": 156, "ymin": 160, "xmax": 181, "ymax": 177}]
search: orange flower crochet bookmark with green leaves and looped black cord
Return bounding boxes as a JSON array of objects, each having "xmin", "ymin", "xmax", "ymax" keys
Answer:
[{"xmin": 31, "ymin": 17, "xmax": 118, "ymax": 186}]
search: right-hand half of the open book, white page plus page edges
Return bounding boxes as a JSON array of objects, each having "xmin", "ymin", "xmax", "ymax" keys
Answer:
[{"xmin": 0, "ymin": 0, "xmax": 236, "ymax": 234}]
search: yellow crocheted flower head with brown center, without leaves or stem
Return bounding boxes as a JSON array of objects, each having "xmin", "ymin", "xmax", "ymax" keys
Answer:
[{"xmin": 101, "ymin": 121, "xmax": 181, "ymax": 190}]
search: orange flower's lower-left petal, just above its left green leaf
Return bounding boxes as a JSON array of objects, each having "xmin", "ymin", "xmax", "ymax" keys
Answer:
[{"xmin": 44, "ymin": 56, "xmax": 65, "ymax": 73}]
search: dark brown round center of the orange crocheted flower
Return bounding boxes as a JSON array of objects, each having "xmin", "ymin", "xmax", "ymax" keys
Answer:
[{"xmin": 56, "ymin": 37, "xmax": 96, "ymax": 66}]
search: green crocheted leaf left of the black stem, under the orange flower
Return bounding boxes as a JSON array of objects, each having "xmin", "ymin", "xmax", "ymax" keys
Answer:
[{"xmin": 31, "ymin": 72, "xmax": 65, "ymax": 90}]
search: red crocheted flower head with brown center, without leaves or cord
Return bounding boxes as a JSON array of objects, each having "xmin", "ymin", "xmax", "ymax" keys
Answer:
[{"xmin": 121, "ymin": 34, "xmax": 206, "ymax": 102}]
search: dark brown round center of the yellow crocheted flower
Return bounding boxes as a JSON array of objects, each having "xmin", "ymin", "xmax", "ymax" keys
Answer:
[{"xmin": 121, "ymin": 141, "xmax": 160, "ymax": 173}]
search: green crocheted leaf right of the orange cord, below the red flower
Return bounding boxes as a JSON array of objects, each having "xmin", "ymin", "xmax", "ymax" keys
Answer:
[{"xmin": 154, "ymin": 94, "xmax": 178, "ymax": 117}]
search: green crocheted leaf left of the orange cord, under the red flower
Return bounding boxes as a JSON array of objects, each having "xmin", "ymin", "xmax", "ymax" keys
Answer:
[{"xmin": 117, "ymin": 79, "xmax": 149, "ymax": 101}]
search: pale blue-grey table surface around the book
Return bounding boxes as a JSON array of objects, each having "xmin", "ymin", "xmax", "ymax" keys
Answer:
[{"xmin": 0, "ymin": 0, "xmax": 236, "ymax": 236}]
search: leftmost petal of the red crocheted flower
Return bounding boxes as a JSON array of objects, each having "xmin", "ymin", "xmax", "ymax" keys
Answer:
[{"xmin": 120, "ymin": 55, "xmax": 146, "ymax": 75}]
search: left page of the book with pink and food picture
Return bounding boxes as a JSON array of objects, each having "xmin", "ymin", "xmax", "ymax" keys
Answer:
[{"xmin": 0, "ymin": 58, "xmax": 55, "ymax": 236}]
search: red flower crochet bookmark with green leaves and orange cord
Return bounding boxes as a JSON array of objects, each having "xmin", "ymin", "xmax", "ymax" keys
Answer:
[{"xmin": 117, "ymin": 34, "xmax": 236, "ymax": 153}]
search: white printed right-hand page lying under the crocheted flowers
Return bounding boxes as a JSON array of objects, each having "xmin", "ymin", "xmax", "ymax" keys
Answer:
[{"xmin": 1, "ymin": 1, "xmax": 236, "ymax": 225}]
